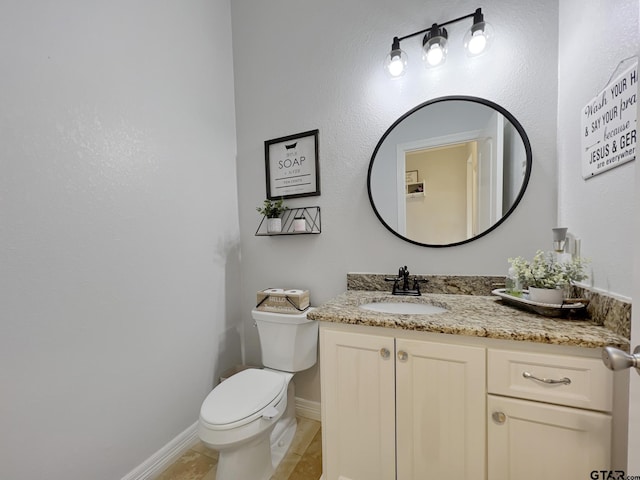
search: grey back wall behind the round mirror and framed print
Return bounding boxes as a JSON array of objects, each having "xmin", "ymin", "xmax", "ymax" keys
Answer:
[{"xmin": 231, "ymin": 0, "xmax": 558, "ymax": 400}]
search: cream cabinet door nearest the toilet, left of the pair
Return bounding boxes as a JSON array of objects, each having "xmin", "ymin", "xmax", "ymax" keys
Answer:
[{"xmin": 320, "ymin": 329, "xmax": 396, "ymax": 480}]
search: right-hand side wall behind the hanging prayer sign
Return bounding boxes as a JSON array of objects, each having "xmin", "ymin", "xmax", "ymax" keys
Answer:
[{"xmin": 558, "ymin": 0, "xmax": 640, "ymax": 297}]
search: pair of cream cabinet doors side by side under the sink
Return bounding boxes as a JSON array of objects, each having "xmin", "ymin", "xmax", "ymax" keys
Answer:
[{"xmin": 320, "ymin": 328, "xmax": 486, "ymax": 480}]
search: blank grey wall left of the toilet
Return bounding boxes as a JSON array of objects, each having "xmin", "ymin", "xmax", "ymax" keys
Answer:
[{"xmin": 0, "ymin": 0, "xmax": 240, "ymax": 480}]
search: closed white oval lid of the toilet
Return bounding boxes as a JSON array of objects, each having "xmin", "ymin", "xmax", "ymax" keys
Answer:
[{"xmin": 200, "ymin": 368, "xmax": 286, "ymax": 425}]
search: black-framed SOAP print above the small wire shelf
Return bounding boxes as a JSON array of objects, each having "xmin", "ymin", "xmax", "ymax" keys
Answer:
[{"xmin": 264, "ymin": 130, "xmax": 320, "ymax": 200}]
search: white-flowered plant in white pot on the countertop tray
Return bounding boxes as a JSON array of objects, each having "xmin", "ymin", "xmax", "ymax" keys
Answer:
[{"xmin": 509, "ymin": 250, "xmax": 589, "ymax": 305}]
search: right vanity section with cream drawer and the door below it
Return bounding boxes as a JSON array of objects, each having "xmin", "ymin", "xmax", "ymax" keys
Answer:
[{"xmin": 487, "ymin": 349, "xmax": 613, "ymax": 480}]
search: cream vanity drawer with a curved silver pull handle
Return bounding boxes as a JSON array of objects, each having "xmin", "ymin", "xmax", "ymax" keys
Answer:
[{"xmin": 487, "ymin": 350, "xmax": 613, "ymax": 412}]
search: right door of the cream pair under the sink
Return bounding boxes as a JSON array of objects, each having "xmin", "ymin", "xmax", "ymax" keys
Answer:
[{"xmin": 396, "ymin": 339, "xmax": 484, "ymax": 480}]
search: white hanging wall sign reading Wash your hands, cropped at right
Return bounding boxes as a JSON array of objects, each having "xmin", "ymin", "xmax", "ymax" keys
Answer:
[{"xmin": 582, "ymin": 60, "xmax": 638, "ymax": 179}]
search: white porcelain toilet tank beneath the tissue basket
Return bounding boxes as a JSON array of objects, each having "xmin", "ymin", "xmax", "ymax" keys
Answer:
[{"xmin": 251, "ymin": 307, "xmax": 318, "ymax": 372}]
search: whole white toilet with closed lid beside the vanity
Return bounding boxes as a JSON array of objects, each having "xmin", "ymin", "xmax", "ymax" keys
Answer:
[{"xmin": 198, "ymin": 307, "xmax": 318, "ymax": 480}]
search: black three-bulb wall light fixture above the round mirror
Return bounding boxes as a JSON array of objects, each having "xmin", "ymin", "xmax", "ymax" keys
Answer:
[{"xmin": 384, "ymin": 8, "xmax": 493, "ymax": 78}]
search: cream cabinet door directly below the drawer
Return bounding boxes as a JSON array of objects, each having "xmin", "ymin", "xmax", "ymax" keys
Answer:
[{"xmin": 487, "ymin": 395, "xmax": 611, "ymax": 480}]
